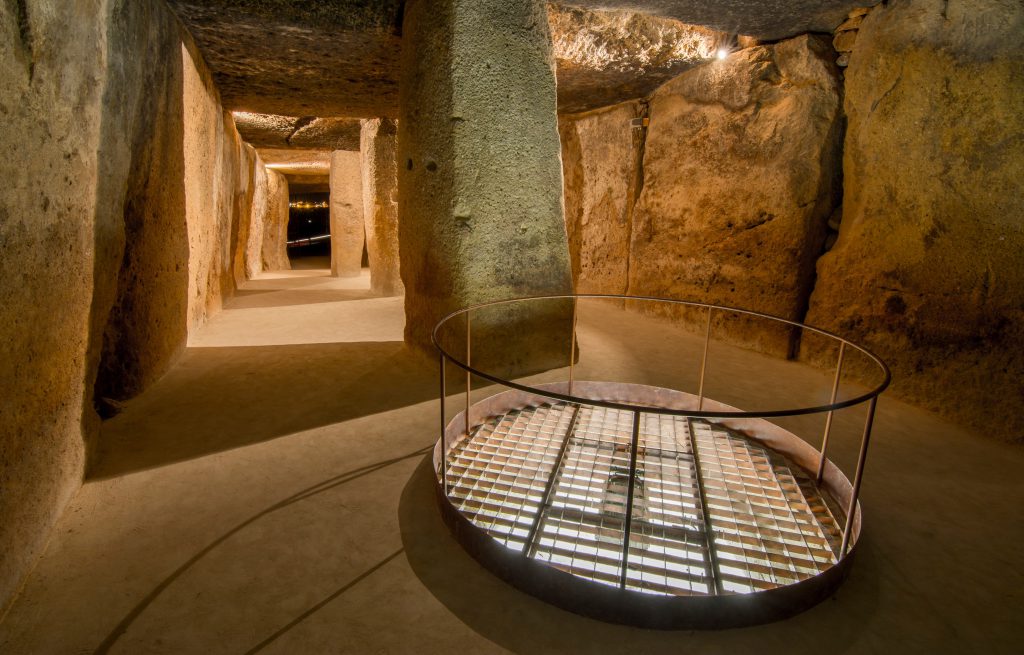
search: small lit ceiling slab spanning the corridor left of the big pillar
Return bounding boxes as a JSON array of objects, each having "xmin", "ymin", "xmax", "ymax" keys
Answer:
[{"xmin": 232, "ymin": 112, "xmax": 359, "ymax": 150}]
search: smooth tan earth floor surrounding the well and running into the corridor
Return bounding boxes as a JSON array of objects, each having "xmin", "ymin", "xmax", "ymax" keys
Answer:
[{"xmin": 0, "ymin": 268, "xmax": 1024, "ymax": 655}]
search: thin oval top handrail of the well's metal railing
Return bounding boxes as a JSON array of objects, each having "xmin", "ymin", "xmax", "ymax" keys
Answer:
[{"xmin": 430, "ymin": 294, "xmax": 892, "ymax": 419}]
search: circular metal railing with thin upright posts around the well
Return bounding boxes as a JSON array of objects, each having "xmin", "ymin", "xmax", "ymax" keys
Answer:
[{"xmin": 431, "ymin": 294, "xmax": 891, "ymax": 626}]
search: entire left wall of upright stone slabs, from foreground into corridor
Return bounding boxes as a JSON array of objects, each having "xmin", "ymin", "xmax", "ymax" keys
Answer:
[{"xmin": 0, "ymin": 0, "xmax": 280, "ymax": 606}]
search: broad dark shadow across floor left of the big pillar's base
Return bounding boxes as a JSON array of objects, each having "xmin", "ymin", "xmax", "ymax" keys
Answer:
[{"xmin": 87, "ymin": 341, "xmax": 437, "ymax": 480}]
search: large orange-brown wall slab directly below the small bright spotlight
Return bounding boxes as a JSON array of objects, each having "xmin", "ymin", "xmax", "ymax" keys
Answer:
[{"xmin": 629, "ymin": 36, "xmax": 841, "ymax": 354}]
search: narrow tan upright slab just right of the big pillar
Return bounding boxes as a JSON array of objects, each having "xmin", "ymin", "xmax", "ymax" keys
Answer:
[{"xmin": 558, "ymin": 102, "xmax": 646, "ymax": 294}]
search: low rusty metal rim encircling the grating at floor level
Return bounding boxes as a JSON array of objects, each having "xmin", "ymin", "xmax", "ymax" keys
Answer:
[{"xmin": 431, "ymin": 383, "xmax": 863, "ymax": 629}]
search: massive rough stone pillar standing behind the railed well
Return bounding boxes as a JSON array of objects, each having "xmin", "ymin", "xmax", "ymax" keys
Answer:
[{"xmin": 398, "ymin": 0, "xmax": 571, "ymax": 373}]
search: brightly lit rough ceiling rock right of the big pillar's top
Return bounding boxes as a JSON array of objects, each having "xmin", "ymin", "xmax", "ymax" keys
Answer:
[{"xmin": 548, "ymin": 5, "xmax": 730, "ymax": 114}]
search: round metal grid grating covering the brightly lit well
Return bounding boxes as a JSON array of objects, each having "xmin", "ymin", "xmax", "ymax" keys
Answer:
[{"xmin": 447, "ymin": 402, "xmax": 842, "ymax": 596}]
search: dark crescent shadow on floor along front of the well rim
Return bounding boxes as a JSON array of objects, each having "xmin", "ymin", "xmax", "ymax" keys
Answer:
[{"xmin": 398, "ymin": 455, "xmax": 878, "ymax": 655}]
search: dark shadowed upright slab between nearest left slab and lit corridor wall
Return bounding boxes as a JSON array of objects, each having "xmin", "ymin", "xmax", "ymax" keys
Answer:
[{"xmin": 93, "ymin": 1, "xmax": 188, "ymax": 405}]
